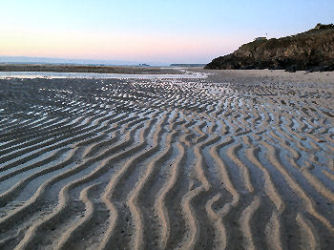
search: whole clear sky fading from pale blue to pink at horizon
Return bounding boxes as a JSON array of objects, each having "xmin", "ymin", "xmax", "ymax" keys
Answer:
[{"xmin": 0, "ymin": 0, "xmax": 334, "ymax": 64}]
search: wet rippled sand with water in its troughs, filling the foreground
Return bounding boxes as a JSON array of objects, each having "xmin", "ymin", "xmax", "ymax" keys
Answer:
[{"xmin": 0, "ymin": 79, "xmax": 334, "ymax": 249}]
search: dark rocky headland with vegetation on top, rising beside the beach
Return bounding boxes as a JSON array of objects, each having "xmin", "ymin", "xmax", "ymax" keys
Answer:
[{"xmin": 205, "ymin": 24, "xmax": 334, "ymax": 71}]
